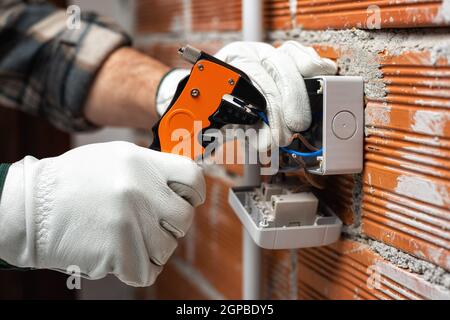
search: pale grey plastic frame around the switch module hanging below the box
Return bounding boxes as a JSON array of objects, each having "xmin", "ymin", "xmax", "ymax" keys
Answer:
[{"xmin": 228, "ymin": 187, "xmax": 342, "ymax": 249}]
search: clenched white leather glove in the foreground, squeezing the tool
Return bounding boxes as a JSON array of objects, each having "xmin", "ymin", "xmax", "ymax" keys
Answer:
[{"xmin": 0, "ymin": 142, "xmax": 205, "ymax": 286}]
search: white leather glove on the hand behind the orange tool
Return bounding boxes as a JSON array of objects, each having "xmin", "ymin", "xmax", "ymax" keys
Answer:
[{"xmin": 157, "ymin": 41, "xmax": 337, "ymax": 150}]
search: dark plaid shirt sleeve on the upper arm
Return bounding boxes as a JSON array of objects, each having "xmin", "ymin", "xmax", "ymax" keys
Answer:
[{"xmin": 0, "ymin": 0, "xmax": 131, "ymax": 131}]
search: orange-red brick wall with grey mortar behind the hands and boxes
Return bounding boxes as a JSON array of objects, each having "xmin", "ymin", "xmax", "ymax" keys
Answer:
[{"xmin": 136, "ymin": 0, "xmax": 450, "ymax": 299}]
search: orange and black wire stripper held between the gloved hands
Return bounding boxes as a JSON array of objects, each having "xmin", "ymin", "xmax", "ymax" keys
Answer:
[{"xmin": 150, "ymin": 46, "xmax": 266, "ymax": 160}]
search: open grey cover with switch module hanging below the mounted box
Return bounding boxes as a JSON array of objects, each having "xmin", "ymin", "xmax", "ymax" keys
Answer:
[{"xmin": 228, "ymin": 183, "xmax": 342, "ymax": 249}]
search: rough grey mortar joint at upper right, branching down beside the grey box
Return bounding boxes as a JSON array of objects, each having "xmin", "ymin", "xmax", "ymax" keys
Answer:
[{"xmin": 268, "ymin": 29, "xmax": 450, "ymax": 99}]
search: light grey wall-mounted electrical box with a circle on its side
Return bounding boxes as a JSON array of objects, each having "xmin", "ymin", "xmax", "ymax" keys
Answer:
[{"xmin": 305, "ymin": 76, "xmax": 364, "ymax": 175}]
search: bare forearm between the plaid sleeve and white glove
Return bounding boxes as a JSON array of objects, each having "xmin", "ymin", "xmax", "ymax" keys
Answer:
[{"xmin": 85, "ymin": 48, "xmax": 169, "ymax": 129}]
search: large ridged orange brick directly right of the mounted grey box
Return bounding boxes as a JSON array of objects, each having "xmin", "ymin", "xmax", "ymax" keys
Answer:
[{"xmin": 362, "ymin": 52, "xmax": 450, "ymax": 269}]
